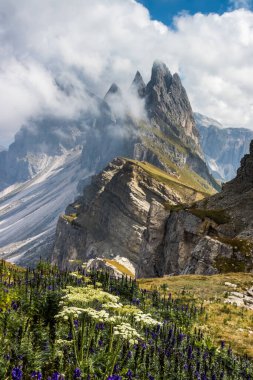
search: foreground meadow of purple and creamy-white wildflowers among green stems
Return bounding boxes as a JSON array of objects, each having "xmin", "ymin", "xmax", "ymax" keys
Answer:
[{"xmin": 0, "ymin": 261, "xmax": 253, "ymax": 380}]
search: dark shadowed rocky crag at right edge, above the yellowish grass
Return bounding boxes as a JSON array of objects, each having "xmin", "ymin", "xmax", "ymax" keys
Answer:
[{"xmin": 163, "ymin": 141, "xmax": 253, "ymax": 274}]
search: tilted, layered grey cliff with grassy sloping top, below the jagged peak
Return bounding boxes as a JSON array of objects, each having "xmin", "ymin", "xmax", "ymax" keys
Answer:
[{"xmin": 53, "ymin": 158, "xmax": 211, "ymax": 276}]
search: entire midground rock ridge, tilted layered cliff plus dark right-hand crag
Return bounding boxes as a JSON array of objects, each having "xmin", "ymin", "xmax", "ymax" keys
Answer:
[{"xmin": 53, "ymin": 142, "xmax": 253, "ymax": 277}]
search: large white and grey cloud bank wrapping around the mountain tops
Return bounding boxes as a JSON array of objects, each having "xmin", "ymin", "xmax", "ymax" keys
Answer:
[{"xmin": 0, "ymin": 0, "xmax": 253, "ymax": 144}]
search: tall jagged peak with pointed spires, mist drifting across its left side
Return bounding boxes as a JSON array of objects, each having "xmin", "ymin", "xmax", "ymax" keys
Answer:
[{"xmin": 82, "ymin": 61, "xmax": 219, "ymax": 189}]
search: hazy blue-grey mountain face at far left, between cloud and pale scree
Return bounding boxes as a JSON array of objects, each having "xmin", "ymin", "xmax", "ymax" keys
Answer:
[{"xmin": 0, "ymin": 94, "xmax": 112, "ymax": 191}]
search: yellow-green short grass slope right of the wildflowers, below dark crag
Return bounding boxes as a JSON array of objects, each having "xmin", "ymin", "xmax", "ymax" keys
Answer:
[{"xmin": 139, "ymin": 273, "xmax": 253, "ymax": 358}]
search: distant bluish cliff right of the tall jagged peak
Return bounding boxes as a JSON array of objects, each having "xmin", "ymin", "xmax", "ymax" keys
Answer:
[{"xmin": 194, "ymin": 113, "xmax": 253, "ymax": 182}]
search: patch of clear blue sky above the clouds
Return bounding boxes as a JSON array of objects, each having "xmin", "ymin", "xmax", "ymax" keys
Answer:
[{"xmin": 138, "ymin": 0, "xmax": 253, "ymax": 25}]
